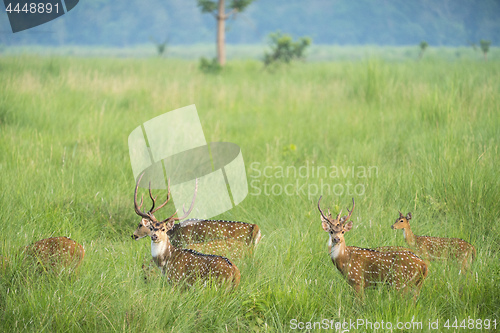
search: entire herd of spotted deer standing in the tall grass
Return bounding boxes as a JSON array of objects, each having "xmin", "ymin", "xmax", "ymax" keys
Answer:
[{"xmin": 0, "ymin": 173, "xmax": 476, "ymax": 299}]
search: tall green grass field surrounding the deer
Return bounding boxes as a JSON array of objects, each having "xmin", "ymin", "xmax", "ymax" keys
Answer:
[{"xmin": 0, "ymin": 56, "xmax": 500, "ymax": 332}]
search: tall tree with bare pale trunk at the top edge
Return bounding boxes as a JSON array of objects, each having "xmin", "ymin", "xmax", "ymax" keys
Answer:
[{"xmin": 197, "ymin": 0, "xmax": 254, "ymax": 66}]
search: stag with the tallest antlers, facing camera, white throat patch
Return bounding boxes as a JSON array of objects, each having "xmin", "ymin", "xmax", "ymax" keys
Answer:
[{"xmin": 134, "ymin": 174, "xmax": 240, "ymax": 287}]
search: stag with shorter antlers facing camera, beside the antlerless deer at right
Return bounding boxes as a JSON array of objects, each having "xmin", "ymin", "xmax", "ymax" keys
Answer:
[{"xmin": 318, "ymin": 197, "xmax": 428, "ymax": 298}]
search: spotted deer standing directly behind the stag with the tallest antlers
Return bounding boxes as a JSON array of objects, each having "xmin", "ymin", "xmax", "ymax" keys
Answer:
[{"xmin": 132, "ymin": 219, "xmax": 261, "ymax": 259}]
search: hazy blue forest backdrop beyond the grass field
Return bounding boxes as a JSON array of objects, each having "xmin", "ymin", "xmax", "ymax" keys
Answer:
[{"xmin": 0, "ymin": 0, "xmax": 500, "ymax": 47}]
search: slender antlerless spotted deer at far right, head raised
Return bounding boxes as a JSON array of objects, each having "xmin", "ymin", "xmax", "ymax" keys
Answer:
[{"xmin": 391, "ymin": 212, "xmax": 476, "ymax": 272}]
